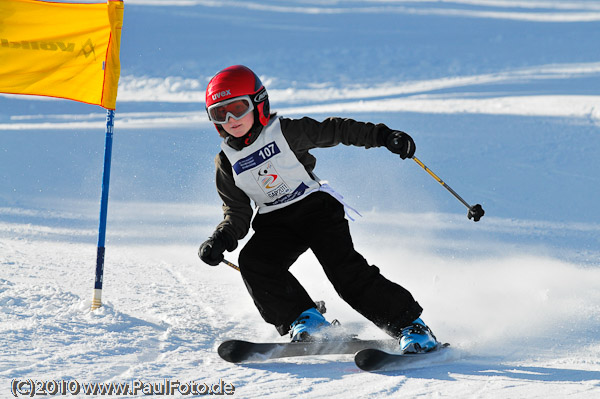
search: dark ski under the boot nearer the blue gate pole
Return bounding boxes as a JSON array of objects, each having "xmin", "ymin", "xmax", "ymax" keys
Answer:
[{"xmin": 218, "ymin": 339, "xmax": 398, "ymax": 363}]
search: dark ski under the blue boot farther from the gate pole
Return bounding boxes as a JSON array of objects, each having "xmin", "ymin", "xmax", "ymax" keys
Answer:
[{"xmin": 354, "ymin": 344, "xmax": 450, "ymax": 371}]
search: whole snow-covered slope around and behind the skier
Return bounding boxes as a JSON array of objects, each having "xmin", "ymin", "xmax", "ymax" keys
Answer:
[{"xmin": 0, "ymin": 0, "xmax": 600, "ymax": 398}]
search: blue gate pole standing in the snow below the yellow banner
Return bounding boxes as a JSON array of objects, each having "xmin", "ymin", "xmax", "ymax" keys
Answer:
[{"xmin": 92, "ymin": 109, "xmax": 115, "ymax": 310}]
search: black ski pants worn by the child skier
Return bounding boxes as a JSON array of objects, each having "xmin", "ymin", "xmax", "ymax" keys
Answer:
[{"xmin": 239, "ymin": 192, "xmax": 423, "ymax": 337}]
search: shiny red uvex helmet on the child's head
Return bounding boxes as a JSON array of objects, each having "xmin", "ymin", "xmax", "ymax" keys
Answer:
[{"xmin": 206, "ymin": 65, "xmax": 270, "ymax": 130}]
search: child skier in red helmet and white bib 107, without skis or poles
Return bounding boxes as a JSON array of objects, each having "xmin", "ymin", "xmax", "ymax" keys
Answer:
[{"xmin": 198, "ymin": 65, "xmax": 437, "ymax": 352}]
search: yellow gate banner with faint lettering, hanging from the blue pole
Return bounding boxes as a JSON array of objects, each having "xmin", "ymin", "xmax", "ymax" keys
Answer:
[{"xmin": 0, "ymin": 0, "xmax": 124, "ymax": 109}]
